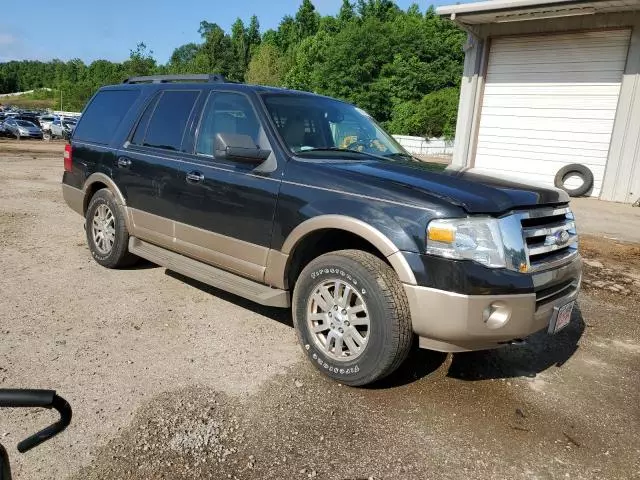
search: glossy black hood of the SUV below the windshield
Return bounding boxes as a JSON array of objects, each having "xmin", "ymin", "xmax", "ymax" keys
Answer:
[{"xmin": 304, "ymin": 159, "xmax": 569, "ymax": 214}]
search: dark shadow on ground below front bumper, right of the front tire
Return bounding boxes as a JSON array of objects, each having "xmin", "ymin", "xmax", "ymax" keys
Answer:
[{"xmin": 447, "ymin": 306, "xmax": 585, "ymax": 381}]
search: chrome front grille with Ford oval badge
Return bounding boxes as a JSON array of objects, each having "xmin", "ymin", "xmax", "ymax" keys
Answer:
[{"xmin": 520, "ymin": 207, "xmax": 578, "ymax": 272}]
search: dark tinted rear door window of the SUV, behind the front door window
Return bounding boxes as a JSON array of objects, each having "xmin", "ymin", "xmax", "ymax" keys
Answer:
[{"xmin": 143, "ymin": 90, "xmax": 199, "ymax": 150}]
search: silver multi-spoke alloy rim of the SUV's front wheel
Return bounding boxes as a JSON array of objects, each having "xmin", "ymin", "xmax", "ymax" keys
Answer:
[{"xmin": 307, "ymin": 279, "xmax": 371, "ymax": 362}]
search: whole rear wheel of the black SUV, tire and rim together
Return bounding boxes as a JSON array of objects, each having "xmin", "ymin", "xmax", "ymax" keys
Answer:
[{"xmin": 85, "ymin": 188, "xmax": 137, "ymax": 268}]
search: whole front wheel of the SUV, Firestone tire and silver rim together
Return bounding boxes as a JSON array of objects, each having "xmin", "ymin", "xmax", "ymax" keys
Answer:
[{"xmin": 293, "ymin": 250, "xmax": 413, "ymax": 386}]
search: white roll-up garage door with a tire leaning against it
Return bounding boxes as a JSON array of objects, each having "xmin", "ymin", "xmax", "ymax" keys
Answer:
[{"xmin": 475, "ymin": 30, "xmax": 630, "ymax": 196}]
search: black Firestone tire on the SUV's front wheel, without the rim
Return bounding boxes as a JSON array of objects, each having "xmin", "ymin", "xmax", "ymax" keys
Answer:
[{"xmin": 293, "ymin": 250, "xmax": 413, "ymax": 386}]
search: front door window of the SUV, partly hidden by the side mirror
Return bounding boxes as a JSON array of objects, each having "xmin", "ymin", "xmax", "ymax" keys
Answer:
[{"xmin": 196, "ymin": 92, "xmax": 266, "ymax": 155}]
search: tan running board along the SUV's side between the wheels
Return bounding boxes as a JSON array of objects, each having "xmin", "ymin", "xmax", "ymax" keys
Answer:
[{"xmin": 129, "ymin": 237, "xmax": 291, "ymax": 308}]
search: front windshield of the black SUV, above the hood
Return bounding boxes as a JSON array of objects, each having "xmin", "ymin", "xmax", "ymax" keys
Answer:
[{"xmin": 263, "ymin": 94, "xmax": 409, "ymax": 157}]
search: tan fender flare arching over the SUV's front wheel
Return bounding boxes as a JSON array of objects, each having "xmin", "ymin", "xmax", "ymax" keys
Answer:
[{"xmin": 278, "ymin": 214, "xmax": 417, "ymax": 285}]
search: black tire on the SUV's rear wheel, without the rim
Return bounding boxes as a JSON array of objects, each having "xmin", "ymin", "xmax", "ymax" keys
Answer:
[{"xmin": 85, "ymin": 188, "xmax": 138, "ymax": 268}]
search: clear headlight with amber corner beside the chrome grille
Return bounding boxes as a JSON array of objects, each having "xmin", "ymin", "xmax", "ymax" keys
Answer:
[{"xmin": 427, "ymin": 218, "xmax": 506, "ymax": 268}]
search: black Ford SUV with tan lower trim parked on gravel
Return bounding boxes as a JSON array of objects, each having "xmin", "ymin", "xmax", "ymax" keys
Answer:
[{"xmin": 63, "ymin": 75, "xmax": 581, "ymax": 385}]
